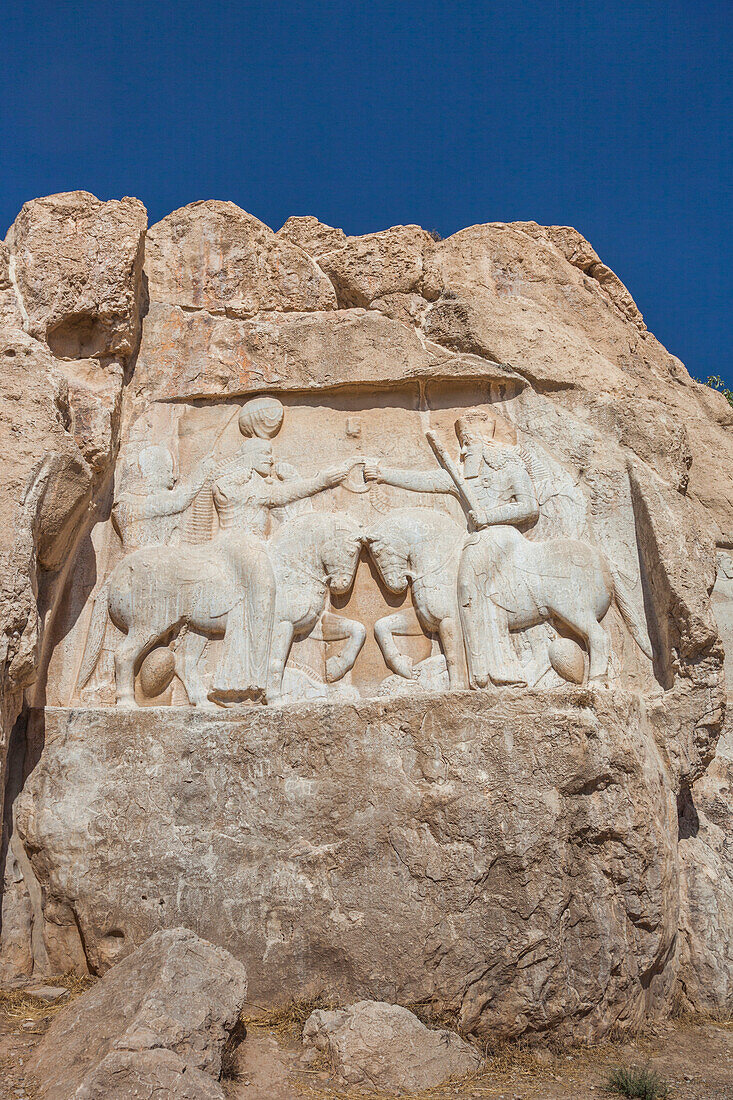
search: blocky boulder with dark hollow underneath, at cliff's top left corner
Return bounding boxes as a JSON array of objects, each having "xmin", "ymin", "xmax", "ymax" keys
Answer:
[{"xmin": 8, "ymin": 191, "xmax": 147, "ymax": 359}]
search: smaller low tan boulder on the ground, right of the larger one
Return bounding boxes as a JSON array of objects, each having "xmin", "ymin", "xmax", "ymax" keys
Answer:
[{"xmin": 303, "ymin": 1001, "xmax": 482, "ymax": 1095}]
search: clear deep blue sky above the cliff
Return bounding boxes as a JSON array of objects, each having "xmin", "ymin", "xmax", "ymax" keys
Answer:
[{"xmin": 0, "ymin": 0, "xmax": 733, "ymax": 384}]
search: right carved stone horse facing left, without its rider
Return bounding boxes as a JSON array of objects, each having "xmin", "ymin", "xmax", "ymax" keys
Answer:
[{"xmin": 365, "ymin": 508, "xmax": 652, "ymax": 688}]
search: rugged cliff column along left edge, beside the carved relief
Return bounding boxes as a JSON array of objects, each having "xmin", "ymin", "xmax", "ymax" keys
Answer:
[{"xmin": 0, "ymin": 191, "xmax": 146, "ymax": 850}]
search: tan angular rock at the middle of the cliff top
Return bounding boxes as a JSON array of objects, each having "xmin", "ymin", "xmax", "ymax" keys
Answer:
[{"xmin": 318, "ymin": 226, "xmax": 434, "ymax": 309}]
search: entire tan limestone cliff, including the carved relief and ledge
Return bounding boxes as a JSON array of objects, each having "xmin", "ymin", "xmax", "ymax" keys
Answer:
[{"xmin": 0, "ymin": 193, "xmax": 733, "ymax": 1042}]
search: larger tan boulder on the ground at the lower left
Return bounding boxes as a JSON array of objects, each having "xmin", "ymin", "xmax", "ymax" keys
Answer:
[{"xmin": 30, "ymin": 928, "xmax": 247, "ymax": 1100}]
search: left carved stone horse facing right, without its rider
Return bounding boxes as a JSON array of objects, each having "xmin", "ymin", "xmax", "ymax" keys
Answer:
[{"xmin": 78, "ymin": 513, "xmax": 365, "ymax": 706}]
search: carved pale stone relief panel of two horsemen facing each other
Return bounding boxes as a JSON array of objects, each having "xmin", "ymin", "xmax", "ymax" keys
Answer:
[{"xmin": 48, "ymin": 383, "xmax": 652, "ymax": 707}]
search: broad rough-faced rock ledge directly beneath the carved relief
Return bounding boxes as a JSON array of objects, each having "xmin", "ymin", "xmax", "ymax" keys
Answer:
[{"xmin": 9, "ymin": 688, "xmax": 678, "ymax": 1038}]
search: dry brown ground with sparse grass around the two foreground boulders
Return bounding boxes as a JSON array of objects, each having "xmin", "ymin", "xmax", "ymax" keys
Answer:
[{"xmin": 0, "ymin": 982, "xmax": 733, "ymax": 1100}]
